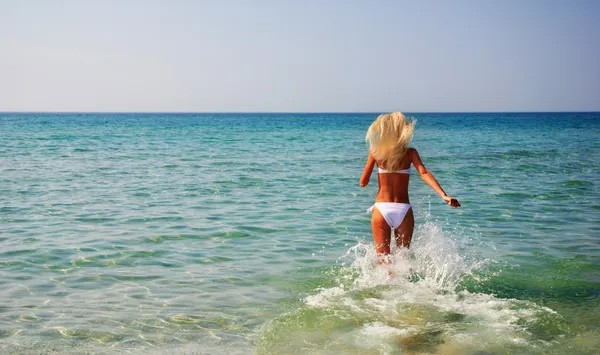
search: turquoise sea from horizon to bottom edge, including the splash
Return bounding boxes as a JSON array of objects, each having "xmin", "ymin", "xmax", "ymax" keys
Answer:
[{"xmin": 0, "ymin": 113, "xmax": 600, "ymax": 354}]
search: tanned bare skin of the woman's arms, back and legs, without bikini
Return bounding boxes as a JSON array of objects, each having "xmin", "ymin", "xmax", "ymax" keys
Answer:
[{"xmin": 360, "ymin": 148, "xmax": 460, "ymax": 255}]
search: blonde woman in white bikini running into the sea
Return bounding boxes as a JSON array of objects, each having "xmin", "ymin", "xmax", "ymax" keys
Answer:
[{"xmin": 360, "ymin": 112, "xmax": 460, "ymax": 256}]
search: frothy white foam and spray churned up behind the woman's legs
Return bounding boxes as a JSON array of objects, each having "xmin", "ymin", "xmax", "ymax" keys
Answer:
[{"xmin": 304, "ymin": 217, "xmax": 552, "ymax": 353}]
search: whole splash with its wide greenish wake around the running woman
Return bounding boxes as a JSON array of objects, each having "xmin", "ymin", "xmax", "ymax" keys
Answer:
[{"xmin": 258, "ymin": 220, "xmax": 568, "ymax": 354}]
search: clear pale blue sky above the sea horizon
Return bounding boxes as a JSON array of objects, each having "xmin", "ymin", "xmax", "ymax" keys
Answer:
[{"xmin": 0, "ymin": 0, "xmax": 600, "ymax": 112}]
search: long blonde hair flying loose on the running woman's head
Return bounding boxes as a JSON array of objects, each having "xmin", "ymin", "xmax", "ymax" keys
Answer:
[{"xmin": 365, "ymin": 112, "xmax": 416, "ymax": 170}]
